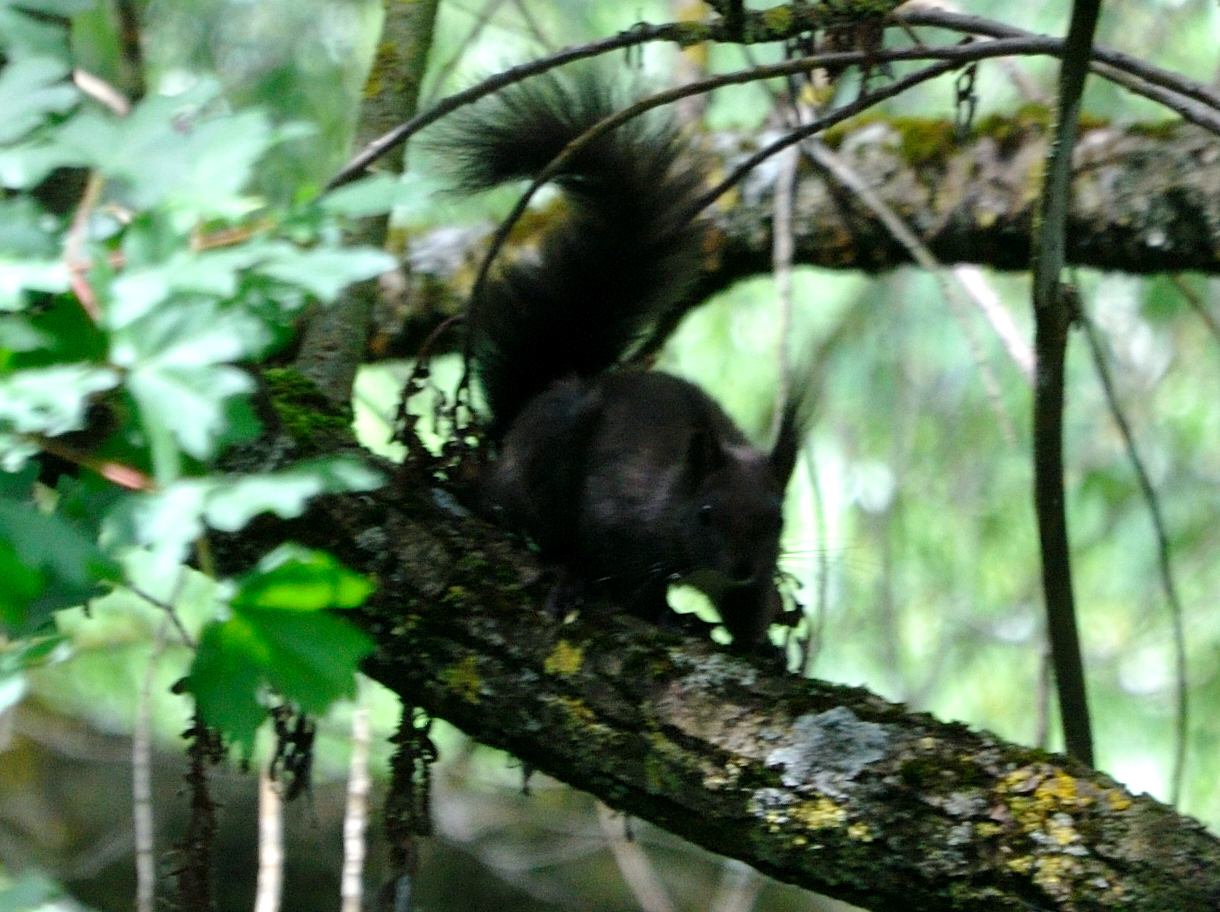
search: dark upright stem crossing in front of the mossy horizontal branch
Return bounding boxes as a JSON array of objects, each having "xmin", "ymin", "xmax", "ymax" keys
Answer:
[{"xmin": 1033, "ymin": 0, "xmax": 1100, "ymax": 766}]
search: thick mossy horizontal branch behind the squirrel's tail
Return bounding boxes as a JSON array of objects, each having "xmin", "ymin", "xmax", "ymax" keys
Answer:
[{"xmin": 387, "ymin": 115, "xmax": 1220, "ymax": 352}]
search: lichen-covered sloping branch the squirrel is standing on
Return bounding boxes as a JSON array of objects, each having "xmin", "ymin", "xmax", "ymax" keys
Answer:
[{"xmin": 254, "ymin": 453, "xmax": 1220, "ymax": 912}]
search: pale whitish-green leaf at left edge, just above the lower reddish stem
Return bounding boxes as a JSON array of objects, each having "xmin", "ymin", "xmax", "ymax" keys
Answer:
[{"xmin": 0, "ymin": 365, "xmax": 118, "ymax": 436}]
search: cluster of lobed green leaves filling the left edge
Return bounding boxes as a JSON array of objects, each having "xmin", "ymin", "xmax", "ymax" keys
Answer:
[{"xmin": 0, "ymin": 0, "xmax": 405, "ymax": 752}]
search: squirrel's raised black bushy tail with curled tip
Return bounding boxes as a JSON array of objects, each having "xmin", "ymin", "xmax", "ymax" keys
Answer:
[{"xmin": 439, "ymin": 68, "xmax": 702, "ymax": 435}]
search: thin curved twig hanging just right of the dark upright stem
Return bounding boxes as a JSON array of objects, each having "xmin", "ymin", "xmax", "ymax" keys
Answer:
[{"xmin": 1076, "ymin": 301, "xmax": 1190, "ymax": 807}]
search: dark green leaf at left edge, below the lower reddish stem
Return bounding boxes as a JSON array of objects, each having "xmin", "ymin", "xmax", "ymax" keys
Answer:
[{"xmin": 0, "ymin": 500, "xmax": 120, "ymax": 634}]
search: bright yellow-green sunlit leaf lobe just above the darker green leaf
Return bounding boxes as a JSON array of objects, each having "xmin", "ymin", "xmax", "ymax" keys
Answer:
[{"xmin": 233, "ymin": 544, "xmax": 373, "ymax": 611}]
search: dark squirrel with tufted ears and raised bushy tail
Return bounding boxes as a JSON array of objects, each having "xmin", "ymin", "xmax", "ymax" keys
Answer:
[{"xmin": 439, "ymin": 69, "xmax": 799, "ymax": 650}]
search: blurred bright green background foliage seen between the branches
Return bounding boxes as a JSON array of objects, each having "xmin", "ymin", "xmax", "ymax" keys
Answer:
[{"xmin": 0, "ymin": 0, "xmax": 1220, "ymax": 912}]
